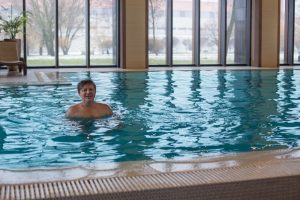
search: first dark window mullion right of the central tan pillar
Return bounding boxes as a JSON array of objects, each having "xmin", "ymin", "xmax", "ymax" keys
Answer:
[{"xmin": 166, "ymin": 0, "xmax": 173, "ymax": 67}]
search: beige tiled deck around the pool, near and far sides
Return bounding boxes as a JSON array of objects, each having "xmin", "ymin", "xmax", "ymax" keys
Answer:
[{"xmin": 0, "ymin": 67, "xmax": 300, "ymax": 200}]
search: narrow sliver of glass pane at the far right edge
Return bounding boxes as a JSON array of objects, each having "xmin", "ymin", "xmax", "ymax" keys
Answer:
[{"xmin": 294, "ymin": 0, "xmax": 300, "ymax": 63}]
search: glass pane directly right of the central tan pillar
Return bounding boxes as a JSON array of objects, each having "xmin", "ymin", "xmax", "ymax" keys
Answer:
[{"xmin": 148, "ymin": 0, "xmax": 167, "ymax": 65}]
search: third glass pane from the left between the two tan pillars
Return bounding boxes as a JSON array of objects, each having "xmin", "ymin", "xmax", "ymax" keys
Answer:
[{"xmin": 200, "ymin": 0, "xmax": 220, "ymax": 64}]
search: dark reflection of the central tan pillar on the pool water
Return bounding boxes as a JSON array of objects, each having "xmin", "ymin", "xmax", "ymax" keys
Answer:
[{"xmin": 106, "ymin": 73, "xmax": 152, "ymax": 162}]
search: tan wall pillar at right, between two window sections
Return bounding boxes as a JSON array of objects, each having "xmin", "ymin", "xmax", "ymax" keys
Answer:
[{"xmin": 251, "ymin": 0, "xmax": 280, "ymax": 68}]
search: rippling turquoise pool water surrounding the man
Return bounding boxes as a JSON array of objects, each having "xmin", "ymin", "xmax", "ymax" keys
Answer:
[{"xmin": 0, "ymin": 70, "xmax": 300, "ymax": 169}]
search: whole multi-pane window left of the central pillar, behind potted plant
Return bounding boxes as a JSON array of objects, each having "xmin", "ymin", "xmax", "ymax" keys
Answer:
[{"xmin": 0, "ymin": 0, "xmax": 118, "ymax": 67}]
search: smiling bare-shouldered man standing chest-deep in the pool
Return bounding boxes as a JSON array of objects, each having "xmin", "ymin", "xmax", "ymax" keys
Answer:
[{"xmin": 66, "ymin": 80, "xmax": 112, "ymax": 118}]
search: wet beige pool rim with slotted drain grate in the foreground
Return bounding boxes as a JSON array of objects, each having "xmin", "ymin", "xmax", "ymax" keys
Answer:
[{"xmin": 0, "ymin": 149, "xmax": 300, "ymax": 199}]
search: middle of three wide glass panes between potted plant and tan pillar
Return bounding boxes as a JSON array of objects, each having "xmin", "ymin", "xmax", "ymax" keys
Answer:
[{"xmin": 58, "ymin": 0, "xmax": 86, "ymax": 66}]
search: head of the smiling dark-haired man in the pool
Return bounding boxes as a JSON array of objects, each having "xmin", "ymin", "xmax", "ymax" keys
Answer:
[{"xmin": 77, "ymin": 80, "xmax": 96, "ymax": 105}]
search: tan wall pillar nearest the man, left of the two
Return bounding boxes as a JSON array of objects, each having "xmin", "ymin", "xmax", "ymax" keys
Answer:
[{"xmin": 120, "ymin": 0, "xmax": 148, "ymax": 69}]
